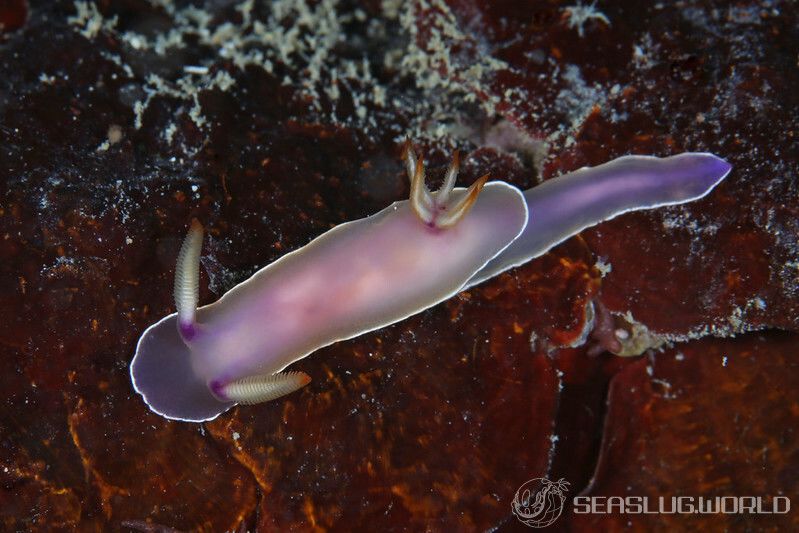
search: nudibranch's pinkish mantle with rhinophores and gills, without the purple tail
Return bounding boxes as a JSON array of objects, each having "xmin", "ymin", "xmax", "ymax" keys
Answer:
[{"xmin": 130, "ymin": 146, "xmax": 527, "ymax": 422}]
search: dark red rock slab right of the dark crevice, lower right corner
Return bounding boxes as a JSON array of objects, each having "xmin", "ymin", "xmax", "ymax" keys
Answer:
[{"xmin": 567, "ymin": 333, "xmax": 799, "ymax": 531}]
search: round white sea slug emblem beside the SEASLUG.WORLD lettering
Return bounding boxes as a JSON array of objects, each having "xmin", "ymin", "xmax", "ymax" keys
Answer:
[{"xmin": 511, "ymin": 477, "xmax": 569, "ymax": 527}]
